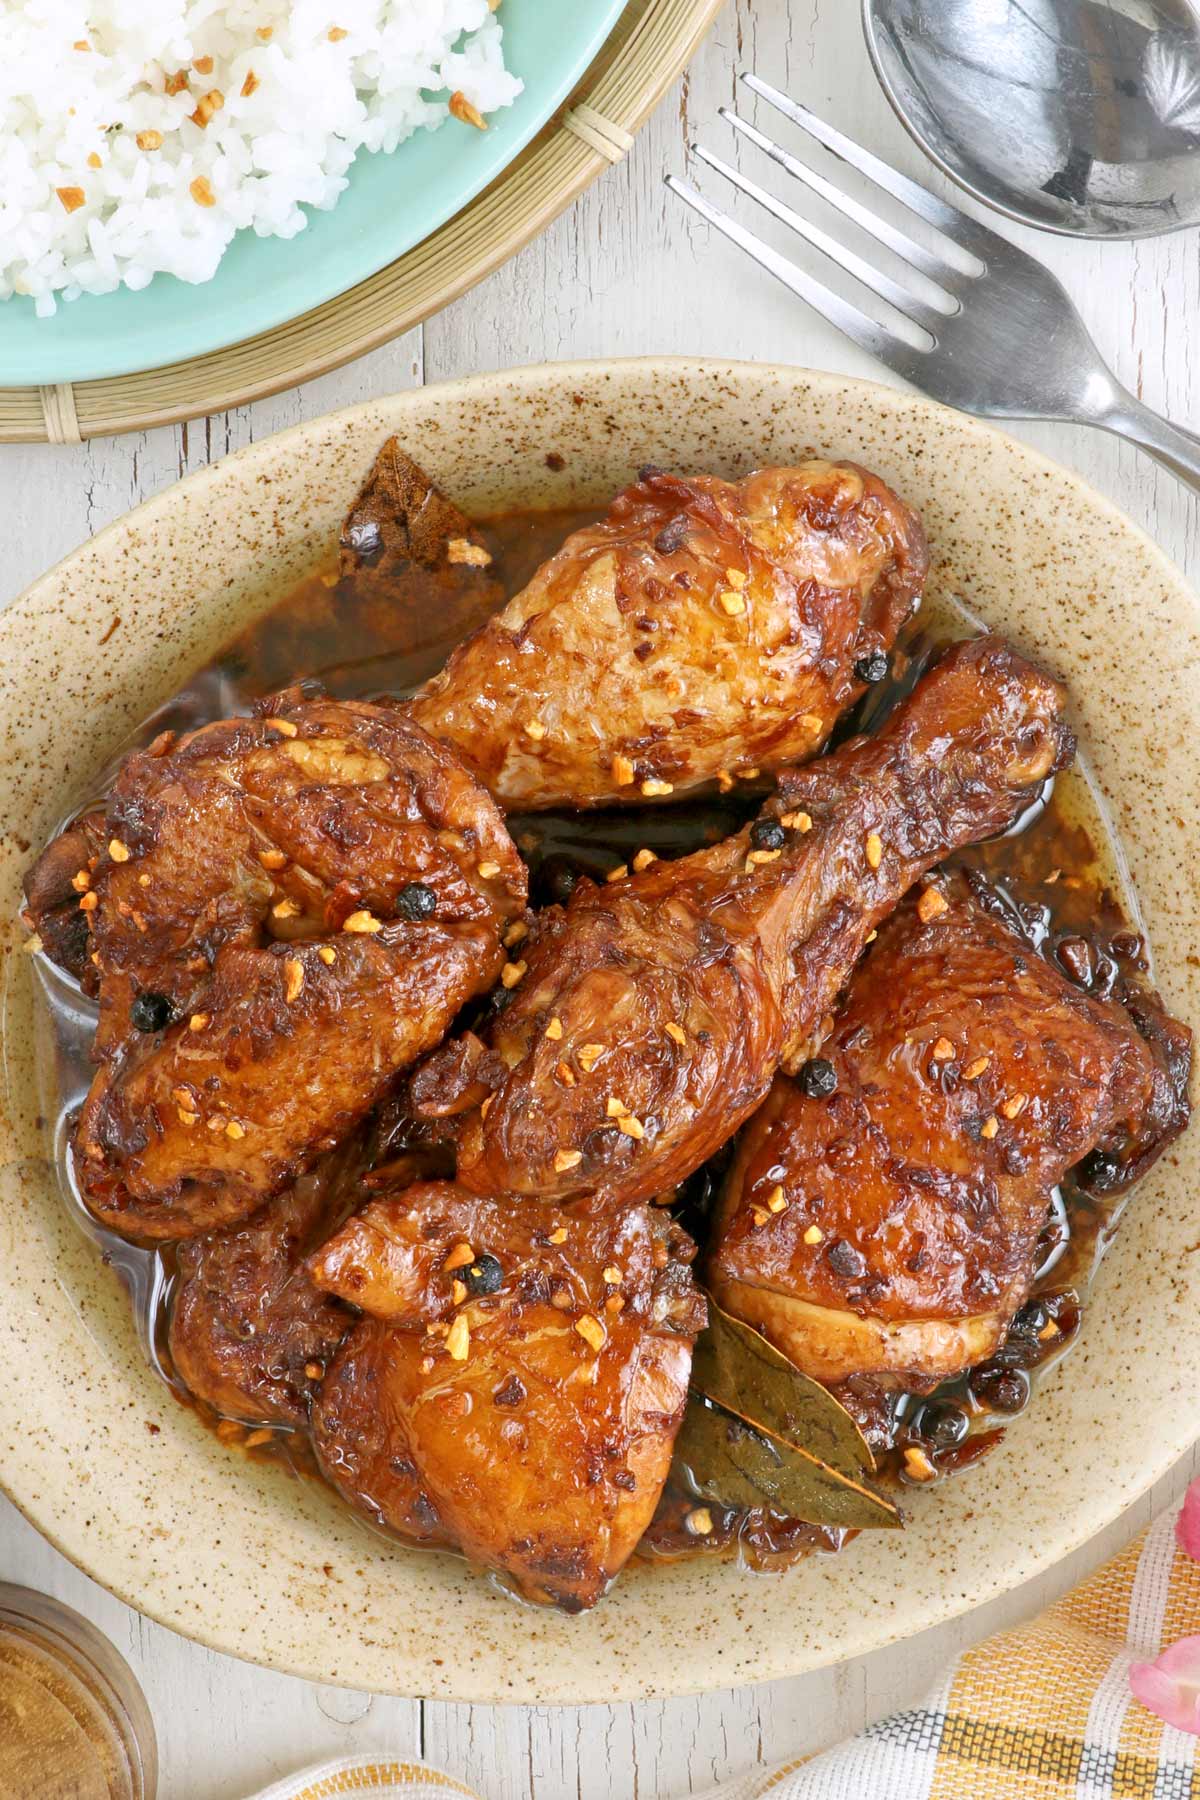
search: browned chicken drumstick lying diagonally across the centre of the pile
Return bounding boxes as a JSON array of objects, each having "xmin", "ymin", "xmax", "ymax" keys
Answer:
[{"xmin": 412, "ymin": 637, "xmax": 1072, "ymax": 1201}]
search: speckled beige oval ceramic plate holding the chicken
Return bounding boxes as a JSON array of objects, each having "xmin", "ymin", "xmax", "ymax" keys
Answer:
[{"xmin": 0, "ymin": 362, "xmax": 1200, "ymax": 1703}]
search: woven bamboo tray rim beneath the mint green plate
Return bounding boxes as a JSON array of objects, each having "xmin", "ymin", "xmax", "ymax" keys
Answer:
[{"xmin": 0, "ymin": 0, "xmax": 723, "ymax": 443}]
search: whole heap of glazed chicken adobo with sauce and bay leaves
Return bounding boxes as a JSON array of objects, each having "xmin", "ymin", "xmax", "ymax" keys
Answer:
[{"xmin": 23, "ymin": 441, "xmax": 1191, "ymax": 1613}]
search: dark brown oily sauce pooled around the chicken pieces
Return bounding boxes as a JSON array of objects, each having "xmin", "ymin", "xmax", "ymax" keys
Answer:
[{"xmin": 28, "ymin": 508, "xmax": 1148, "ymax": 1568}]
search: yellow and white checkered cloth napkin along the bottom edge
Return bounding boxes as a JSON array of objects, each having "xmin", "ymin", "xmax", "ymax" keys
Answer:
[{"xmin": 246, "ymin": 1481, "xmax": 1200, "ymax": 1800}]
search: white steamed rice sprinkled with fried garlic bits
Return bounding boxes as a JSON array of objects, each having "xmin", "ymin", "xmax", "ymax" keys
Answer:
[{"xmin": 0, "ymin": 0, "xmax": 522, "ymax": 313}]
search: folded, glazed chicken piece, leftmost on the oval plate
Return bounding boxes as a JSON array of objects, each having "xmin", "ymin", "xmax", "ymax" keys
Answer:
[{"xmin": 48, "ymin": 693, "xmax": 525, "ymax": 1238}]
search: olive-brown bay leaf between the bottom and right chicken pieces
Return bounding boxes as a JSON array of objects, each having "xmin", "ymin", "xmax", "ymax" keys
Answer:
[{"xmin": 676, "ymin": 1296, "xmax": 901, "ymax": 1528}]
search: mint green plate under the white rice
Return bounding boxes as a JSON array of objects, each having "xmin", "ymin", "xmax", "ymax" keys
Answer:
[{"xmin": 0, "ymin": 0, "xmax": 624, "ymax": 387}]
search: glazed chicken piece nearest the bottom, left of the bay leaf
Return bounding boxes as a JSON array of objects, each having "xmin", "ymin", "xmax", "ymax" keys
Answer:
[{"xmin": 309, "ymin": 1183, "xmax": 703, "ymax": 1611}]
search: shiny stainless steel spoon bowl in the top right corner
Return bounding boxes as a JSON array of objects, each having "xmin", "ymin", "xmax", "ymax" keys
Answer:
[{"xmin": 864, "ymin": 0, "xmax": 1200, "ymax": 238}]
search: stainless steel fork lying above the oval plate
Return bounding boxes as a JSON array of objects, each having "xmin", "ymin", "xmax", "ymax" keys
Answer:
[{"xmin": 666, "ymin": 74, "xmax": 1200, "ymax": 490}]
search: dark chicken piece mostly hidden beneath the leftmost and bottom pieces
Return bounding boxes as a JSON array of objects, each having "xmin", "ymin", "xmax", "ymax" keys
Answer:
[{"xmin": 169, "ymin": 1152, "xmax": 354, "ymax": 1427}]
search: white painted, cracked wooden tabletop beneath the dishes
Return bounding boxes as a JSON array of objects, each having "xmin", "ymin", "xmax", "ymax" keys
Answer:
[{"xmin": 0, "ymin": 0, "xmax": 1200, "ymax": 1800}]
